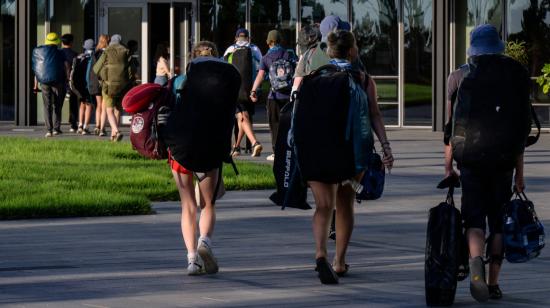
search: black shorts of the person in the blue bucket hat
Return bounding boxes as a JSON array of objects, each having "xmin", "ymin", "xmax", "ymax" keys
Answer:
[{"xmin": 460, "ymin": 168, "xmax": 514, "ymax": 234}]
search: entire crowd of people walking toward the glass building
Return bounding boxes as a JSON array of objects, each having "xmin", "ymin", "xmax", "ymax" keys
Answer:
[{"xmin": 33, "ymin": 15, "xmax": 529, "ymax": 301}]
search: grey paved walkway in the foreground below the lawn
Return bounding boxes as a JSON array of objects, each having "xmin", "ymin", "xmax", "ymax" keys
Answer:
[{"xmin": 0, "ymin": 130, "xmax": 550, "ymax": 307}]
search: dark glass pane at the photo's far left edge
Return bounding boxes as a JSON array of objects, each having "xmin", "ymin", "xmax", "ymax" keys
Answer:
[{"xmin": 0, "ymin": 0, "xmax": 17, "ymax": 121}]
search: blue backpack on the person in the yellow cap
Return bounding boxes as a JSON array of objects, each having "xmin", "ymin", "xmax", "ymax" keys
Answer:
[{"xmin": 32, "ymin": 45, "xmax": 66, "ymax": 85}]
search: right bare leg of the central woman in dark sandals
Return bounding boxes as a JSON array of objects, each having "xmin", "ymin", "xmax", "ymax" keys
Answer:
[{"xmin": 333, "ymin": 185, "xmax": 355, "ymax": 272}]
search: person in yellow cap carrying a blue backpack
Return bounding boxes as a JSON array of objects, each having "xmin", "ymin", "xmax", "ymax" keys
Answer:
[{"xmin": 32, "ymin": 32, "xmax": 70, "ymax": 137}]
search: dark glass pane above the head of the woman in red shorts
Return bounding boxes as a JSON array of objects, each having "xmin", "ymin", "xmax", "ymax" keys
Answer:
[{"xmin": 199, "ymin": 0, "xmax": 246, "ymax": 54}]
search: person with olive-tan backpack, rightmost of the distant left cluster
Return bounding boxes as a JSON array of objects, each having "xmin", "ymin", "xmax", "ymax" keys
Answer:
[{"xmin": 93, "ymin": 34, "xmax": 133, "ymax": 142}]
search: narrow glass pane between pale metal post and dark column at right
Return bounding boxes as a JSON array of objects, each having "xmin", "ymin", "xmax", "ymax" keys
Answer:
[{"xmin": 403, "ymin": 0, "xmax": 433, "ymax": 126}]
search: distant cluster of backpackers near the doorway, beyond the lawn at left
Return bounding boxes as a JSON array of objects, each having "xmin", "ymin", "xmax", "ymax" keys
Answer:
[{"xmin": 32, "ymin": 32, "xmax": 139, "ymax": 142}]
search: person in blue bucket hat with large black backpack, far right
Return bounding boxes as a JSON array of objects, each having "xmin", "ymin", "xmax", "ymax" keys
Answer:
[{"xmin": 444, "ymin": 24, "xmax": 530, "ymax": 302}]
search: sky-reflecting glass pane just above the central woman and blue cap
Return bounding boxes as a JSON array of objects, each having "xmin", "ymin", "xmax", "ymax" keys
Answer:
[{"xmin": 301, "ymin": 0, "xmax": 350, "ymax": 25}]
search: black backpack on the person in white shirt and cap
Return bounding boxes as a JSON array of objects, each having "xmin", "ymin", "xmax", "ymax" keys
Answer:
[{"xmin": 226, "ymin": 46, "xmax": 254, "ymax": 102}]
